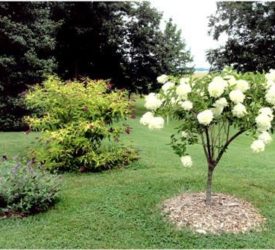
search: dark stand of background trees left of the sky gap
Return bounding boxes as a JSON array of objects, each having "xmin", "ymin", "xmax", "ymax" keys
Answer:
[{"xmin": 0, "ymin": 2, "xmax": 192, "ymax": 130}]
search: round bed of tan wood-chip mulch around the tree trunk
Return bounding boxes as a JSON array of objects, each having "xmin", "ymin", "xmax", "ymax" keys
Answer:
[{"xmin": 162, "ymin": 193, "xmax": 266, "ymax": 234}]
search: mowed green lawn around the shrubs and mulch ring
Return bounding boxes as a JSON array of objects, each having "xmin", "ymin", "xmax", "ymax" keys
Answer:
[{"xmin": 0, "ymin": 97, "xmax": 275, "ymax": 248}]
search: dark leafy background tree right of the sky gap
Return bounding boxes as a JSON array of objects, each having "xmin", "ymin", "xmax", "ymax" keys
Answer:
[{"xmin": 207, "ymin": 2, "xmax": 275, "ymax": 71}]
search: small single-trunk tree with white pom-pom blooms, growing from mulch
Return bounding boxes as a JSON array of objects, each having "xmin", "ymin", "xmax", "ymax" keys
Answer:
[{"xmin": 140, "ymin": 68, "xmax": 275, "ymax": 205}]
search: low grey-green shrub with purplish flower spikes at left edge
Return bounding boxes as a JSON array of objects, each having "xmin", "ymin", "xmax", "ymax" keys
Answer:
[{"xmin": 0, "ymin": 161, "xmax": 60, "ymax": 214}]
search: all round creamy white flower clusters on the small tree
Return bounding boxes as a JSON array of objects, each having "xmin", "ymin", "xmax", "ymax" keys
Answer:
[{"xmin": 143, "ymin": 70, "xmax": 275, "ymax": 164}]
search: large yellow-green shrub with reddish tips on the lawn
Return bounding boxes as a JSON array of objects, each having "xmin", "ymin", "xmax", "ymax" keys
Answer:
[{"xmin": 26, "ymin": 77, "xmax": 136, "ymax": 171}]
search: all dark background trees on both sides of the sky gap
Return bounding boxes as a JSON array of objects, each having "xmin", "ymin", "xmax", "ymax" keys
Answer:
[{"xmin": 0, "ymin": 2, "xmax": 275, "ymax": 130}]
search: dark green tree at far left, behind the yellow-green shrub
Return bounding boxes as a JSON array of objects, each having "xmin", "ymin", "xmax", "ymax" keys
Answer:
[{"xmin": 0, "ymin": 2, "xmax": 57, "ymax": 130}]
